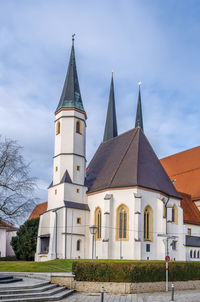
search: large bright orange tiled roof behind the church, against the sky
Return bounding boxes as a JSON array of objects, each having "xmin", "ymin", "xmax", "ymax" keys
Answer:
[{"xmin": 160, "ymin": 147, "xmax": 200, "ymax": 200}]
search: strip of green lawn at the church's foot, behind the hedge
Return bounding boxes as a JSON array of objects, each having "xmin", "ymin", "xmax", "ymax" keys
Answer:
[{"xmin": 0, "ymin": 259, "xmax": 166, "ymax": 272}]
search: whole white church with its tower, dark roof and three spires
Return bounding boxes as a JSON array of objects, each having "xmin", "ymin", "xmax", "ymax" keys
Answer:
[{"xmin": 35, "ymin": 41, "xmax": 200, "ymax": 261}]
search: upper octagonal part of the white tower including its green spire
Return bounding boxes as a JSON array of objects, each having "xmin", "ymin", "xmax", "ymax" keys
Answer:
[{"xmin": 53, "ymin": 35, "xmax": 86, "ymax": 185}]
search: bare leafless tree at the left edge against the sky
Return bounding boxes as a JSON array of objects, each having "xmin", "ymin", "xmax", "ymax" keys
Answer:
[{"xmin": 0, "ymin": 138, "xmax": 35, "ymax": 223}]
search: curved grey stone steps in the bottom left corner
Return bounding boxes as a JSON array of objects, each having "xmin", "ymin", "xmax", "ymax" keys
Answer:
[{"xmin": 0, "ymin": 279, "xmax": 74, "ymax": 302}]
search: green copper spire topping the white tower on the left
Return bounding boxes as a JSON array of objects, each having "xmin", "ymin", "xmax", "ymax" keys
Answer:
[{"xmin": 56, "ymin": 34, "xmax": 85, "ymax": 112}]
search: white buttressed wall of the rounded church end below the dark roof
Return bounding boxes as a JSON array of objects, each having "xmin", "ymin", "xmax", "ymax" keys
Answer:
[{"xmin": 88, "ymin": 188, "xmax": 185, "ymax": 260}]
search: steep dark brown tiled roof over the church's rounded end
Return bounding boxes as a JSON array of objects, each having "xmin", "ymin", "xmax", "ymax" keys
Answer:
[{"xmin": 86, "ymin": 128, "xmax": 180, "ymax": 198}]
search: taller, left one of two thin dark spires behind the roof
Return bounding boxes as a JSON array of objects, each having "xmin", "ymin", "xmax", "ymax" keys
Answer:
[{"xmin": 103, "ymin": 72, "xmax": 118, "ymax": 142}]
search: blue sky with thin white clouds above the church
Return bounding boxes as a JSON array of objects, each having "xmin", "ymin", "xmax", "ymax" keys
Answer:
[{"xmin": 0, "ymin": 0, "xmax": 200, "ymax": 202}]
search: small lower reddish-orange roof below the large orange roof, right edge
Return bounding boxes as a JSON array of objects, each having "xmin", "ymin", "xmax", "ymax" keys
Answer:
[{"xmin": 179, "ymin": 192, "xmax": 200, "ymax": 225}]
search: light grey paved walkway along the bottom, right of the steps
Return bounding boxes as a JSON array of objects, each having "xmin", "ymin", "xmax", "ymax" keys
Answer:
[{"xmin": 60, "ymin": 290, "xmax": 200, "ymax": 302}]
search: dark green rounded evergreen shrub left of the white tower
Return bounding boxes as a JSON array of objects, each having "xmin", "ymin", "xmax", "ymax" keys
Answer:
[{"xmin": 11, "ymin": 218, "xmax": 39, "ymax": 261}]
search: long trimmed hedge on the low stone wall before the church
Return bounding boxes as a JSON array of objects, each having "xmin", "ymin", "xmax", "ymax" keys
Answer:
[{"xmin": 72, "ymin": 261, "xmax": 200, "ymax": 283}]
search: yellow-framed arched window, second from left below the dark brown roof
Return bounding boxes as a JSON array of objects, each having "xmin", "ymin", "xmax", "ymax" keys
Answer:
[{"xmin": 116, "ymin": 204, "xmax": 129, "ymax": 240}]
